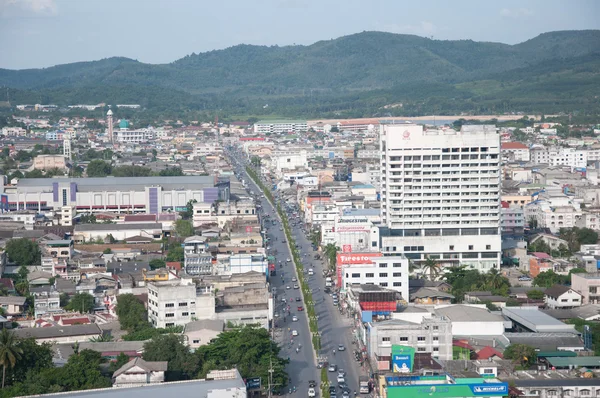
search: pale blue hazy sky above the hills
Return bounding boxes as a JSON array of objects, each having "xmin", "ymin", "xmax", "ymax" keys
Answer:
[{"xmin": 0, "ymin": 0, "xmax": 600, "ymax": 69}]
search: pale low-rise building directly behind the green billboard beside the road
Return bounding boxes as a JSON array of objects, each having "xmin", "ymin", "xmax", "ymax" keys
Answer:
[{"xmin": 367, "ymin": 317, "xmax": 452, "ymax": 370}]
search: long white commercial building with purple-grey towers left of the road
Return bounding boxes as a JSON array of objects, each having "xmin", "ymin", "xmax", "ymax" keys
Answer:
[{"xmin": 4, "ymin": 176, "xmax": 229, "ymax": 214}]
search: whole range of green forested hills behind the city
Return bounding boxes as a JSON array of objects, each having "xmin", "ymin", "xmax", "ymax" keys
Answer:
[{"xmin": 0, "ymin": 31, "xmax": 600, "ymax": 115}]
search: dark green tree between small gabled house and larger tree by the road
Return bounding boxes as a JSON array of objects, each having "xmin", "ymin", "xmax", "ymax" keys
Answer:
[{"xmin": 142, "ymin": 334, "xmax": 200, "ymax": 381}]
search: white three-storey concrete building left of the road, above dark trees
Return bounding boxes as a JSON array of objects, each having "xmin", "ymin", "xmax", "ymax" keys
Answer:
[{"xmin": 147, "ymin": 279, "xmax": 215, "ymax": 328}]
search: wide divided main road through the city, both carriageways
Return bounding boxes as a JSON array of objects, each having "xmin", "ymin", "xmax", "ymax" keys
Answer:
[{"xmin": 230, "ymin": 145, "xmax": 367, "ymax": 397}]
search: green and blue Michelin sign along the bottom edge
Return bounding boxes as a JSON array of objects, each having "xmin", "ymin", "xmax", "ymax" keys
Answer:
[{"xmin": 387, "ymin": 383, "xmax": 508, "ymax": 398}]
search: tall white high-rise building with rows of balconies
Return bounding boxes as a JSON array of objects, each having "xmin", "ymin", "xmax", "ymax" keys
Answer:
[{"xmin": 380, "ymin": 124, "xmax": 501, "ymax": 271}]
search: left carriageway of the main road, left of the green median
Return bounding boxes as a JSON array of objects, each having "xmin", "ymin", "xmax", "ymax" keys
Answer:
[{"xmin": 227, "ymin": 148, "xmax": 320, "ymax": 397}]
